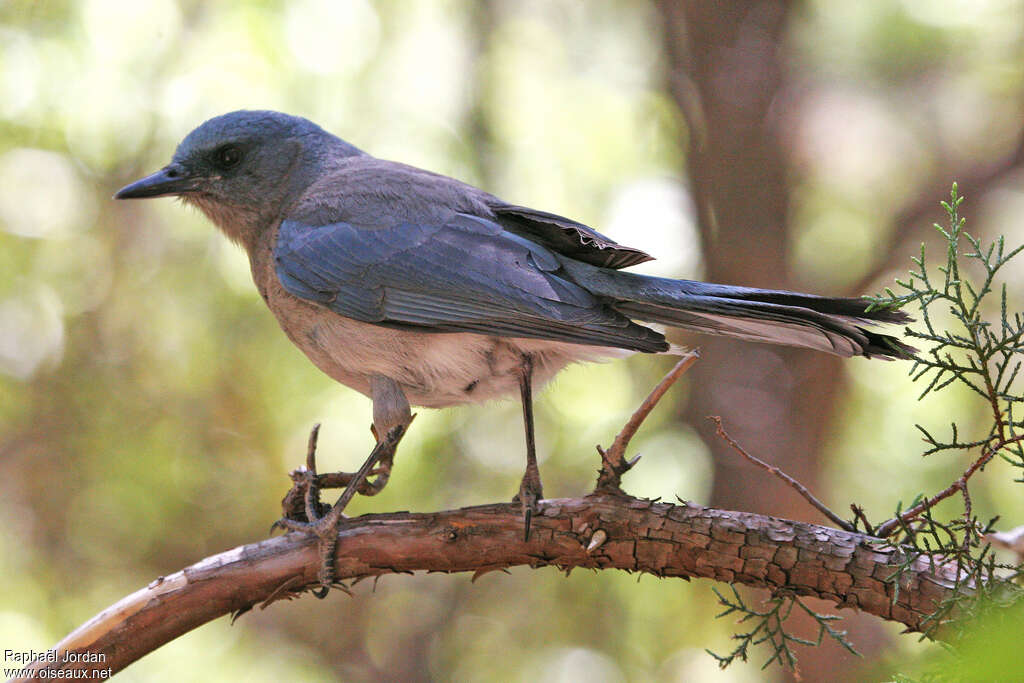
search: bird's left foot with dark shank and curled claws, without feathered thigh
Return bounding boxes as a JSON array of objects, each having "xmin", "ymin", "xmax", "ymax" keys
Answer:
[{"xmin": 270, "ymin": 425, "xmax": 408, "ymax": 598}]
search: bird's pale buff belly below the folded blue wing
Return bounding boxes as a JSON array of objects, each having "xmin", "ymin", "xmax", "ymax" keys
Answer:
[{"xmin": 279, "ymin": 311, "xmax": 629, "ymax": 408}]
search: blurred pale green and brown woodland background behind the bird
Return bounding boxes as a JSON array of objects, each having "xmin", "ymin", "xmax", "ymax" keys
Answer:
[{"xmin": 0, "ymin": 0, "xmax": 1024, "ymax": 681}]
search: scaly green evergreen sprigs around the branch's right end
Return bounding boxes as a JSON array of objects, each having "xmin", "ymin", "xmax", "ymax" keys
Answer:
[{"xmin": 709, "ymin": 183, "xmax": 1024, "ymax": 680}]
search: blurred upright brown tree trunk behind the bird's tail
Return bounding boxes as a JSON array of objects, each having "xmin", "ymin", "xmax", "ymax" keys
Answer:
[{"xmin": 657, "ymin": 0, "xmax": 880, "ymax": 681}]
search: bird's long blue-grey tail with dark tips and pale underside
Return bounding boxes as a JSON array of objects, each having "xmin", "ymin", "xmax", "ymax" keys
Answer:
[{"xmin": 563, "ymin": 259, "xmax": 916, "ymax": 359}]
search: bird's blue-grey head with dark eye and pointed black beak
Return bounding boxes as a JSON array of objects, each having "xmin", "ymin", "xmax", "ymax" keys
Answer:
[{"xmin": 114, "ymin": 111, "xmax": 361, "ymax": 247}]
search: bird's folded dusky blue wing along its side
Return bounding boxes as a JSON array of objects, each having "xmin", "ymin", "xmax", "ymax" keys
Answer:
[{"xmin": 274, "ymin": 214, "xmax": 668, "ymax": 351}]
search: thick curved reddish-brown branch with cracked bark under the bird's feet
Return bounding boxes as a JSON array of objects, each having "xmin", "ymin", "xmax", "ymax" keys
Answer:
[{"xmin": 13, "ymin": 495, "xmax": 955, "ymax": 680}]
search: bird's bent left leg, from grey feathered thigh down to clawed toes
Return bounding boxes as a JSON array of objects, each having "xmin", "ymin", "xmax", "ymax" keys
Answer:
[{"xmin": 271, "ymin": 377, "xmax": 415, "ymax": 598}]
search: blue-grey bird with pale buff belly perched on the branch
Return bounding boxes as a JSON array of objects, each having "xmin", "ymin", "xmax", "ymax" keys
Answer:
[{"xmin": 115, "ymin": 111, "xmax": 914, "ymax": 581}]
